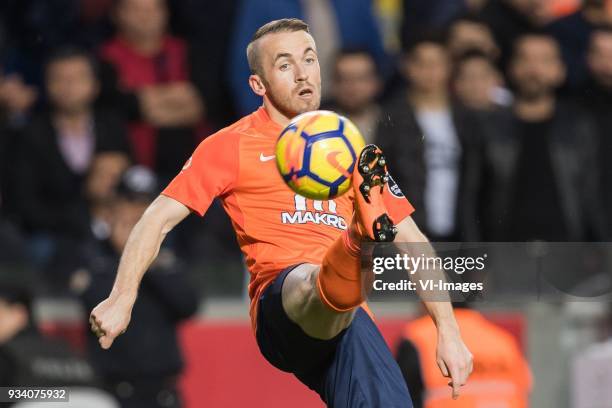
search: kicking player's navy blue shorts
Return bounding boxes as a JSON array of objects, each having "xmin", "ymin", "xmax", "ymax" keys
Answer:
[{"xmin": 257, "ymin": 265, "xmax": 412, "ymax": 408}]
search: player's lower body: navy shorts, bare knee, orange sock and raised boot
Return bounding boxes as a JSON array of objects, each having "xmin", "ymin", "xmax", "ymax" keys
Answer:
[{"xmin": 260, "ymin": 147, "xmax": 412, "ymax": 408}]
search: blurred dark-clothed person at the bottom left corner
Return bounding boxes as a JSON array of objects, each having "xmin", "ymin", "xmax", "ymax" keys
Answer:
[{"xmin": 0, "ymin": 277, "xmax": 95, "ymax": 387}]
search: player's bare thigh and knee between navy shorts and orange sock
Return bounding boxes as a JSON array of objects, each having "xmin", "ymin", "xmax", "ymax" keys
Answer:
[{"xmin": 282, "ymin": 264, "xmax": 355, "ymax": 340}]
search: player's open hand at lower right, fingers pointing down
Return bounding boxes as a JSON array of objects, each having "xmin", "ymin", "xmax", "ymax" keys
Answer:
[{"xmin": 436, "ymin": 328, "xmax": 473, "ymax": 399}]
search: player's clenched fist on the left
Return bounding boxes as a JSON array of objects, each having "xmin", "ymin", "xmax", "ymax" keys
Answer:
[{"xmin": 89, "ymin": 295, "xmax": 136, "ymax": 349}]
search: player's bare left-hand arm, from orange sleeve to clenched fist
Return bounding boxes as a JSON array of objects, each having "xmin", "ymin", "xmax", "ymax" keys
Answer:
[{"xmin": 89, "ymin": 195, "xmax": 189, "ymax": 349}]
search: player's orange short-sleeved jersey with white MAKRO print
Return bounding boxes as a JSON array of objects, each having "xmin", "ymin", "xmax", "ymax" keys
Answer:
[{"xmin": 162, "ymin": 107, "xmax": 414, "ymax": 327}]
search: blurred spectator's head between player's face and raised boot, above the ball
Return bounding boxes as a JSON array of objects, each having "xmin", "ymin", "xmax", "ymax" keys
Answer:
[{"xmin": 327, "ymin": 49, "xmax": 382, "ymax": 143}]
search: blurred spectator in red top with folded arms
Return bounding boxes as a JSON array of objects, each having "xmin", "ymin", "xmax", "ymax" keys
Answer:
[{"xmin": 100, "ymin": 0, "xmax": 204, "ymax": 182}]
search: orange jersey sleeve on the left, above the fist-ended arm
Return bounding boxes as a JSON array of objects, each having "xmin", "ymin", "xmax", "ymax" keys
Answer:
[{"xmin": 162, "ymin": 132, "xmax": 239, "ymax": 216}]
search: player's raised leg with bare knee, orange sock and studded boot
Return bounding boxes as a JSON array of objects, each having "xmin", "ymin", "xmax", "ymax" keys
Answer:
[{"xmin": 282, "ymin": 145, "xmax": 396, "ymax": 339}]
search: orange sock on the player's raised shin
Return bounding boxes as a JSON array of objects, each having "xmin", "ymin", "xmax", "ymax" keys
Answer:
[{"xmin": 317, "ymin": 225, "xmax": 366, "ymax": 312}]
